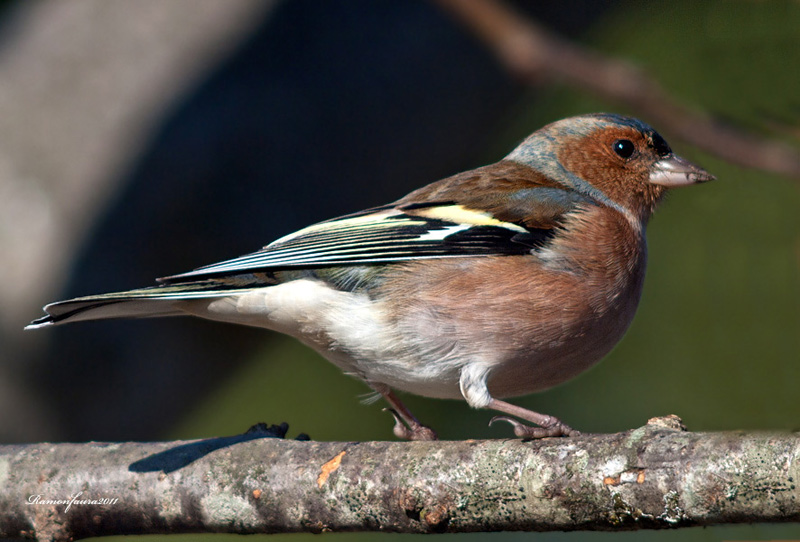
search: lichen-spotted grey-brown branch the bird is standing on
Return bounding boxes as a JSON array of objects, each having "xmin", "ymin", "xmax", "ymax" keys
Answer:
[{"xmin": 0, "ymin": 417, "xmax": 800, "ymax": 540}]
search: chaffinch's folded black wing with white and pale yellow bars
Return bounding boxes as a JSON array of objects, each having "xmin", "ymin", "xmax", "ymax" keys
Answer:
[{"xmin": 159, "ymin": 202, "xmax": 553, "ymax": 284}]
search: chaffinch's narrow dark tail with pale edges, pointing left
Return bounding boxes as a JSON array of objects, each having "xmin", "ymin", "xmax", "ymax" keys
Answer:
[{"xmin": 25, "ymin": 281, "xmax": 241, "ymax": 329}]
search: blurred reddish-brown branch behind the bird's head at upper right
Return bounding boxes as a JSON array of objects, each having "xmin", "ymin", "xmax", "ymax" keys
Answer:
[{"xmin": 436, "ymin": 0, "xmax": 800, "ymax": 178}]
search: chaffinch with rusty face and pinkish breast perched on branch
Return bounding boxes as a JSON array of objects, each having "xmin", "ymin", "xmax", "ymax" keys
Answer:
[{"xmin": 28, "ymin": 113, "xmax": 714, "ymax": 439}]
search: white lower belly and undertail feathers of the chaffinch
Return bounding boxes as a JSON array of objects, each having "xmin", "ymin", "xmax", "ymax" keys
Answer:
[{"xmin": 179, "ymin": 279, "xmax": 461, "ymax": 398}]
